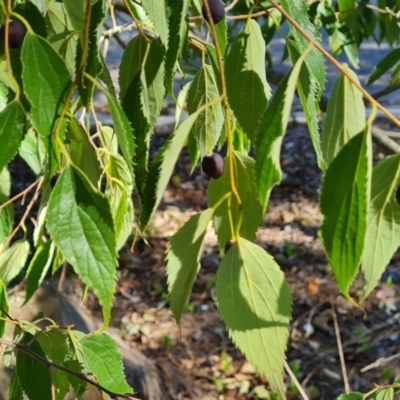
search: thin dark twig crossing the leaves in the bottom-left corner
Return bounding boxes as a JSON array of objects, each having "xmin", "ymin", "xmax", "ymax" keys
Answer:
[{"xmin": 0, "ymin": 339, "xmax": 139, "ymax": 400}]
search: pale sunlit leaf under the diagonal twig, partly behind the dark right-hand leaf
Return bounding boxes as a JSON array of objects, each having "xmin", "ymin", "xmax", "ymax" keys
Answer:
[{"xmin": 321, "ymin": 67, "xmax": 365, "ymax": 165}]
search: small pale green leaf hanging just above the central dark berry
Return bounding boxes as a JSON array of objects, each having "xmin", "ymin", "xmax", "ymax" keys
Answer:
[{"xmin": 187, "ymin": 65, "xmax": 224, "ymax": 157}]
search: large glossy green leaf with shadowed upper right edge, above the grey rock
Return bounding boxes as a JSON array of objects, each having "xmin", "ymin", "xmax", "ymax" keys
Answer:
[{"xmin": 47, "ymin": 166, "xmax": 117, "ymax": 326}]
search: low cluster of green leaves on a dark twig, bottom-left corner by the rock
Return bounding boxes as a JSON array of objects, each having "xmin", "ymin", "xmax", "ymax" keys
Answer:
[{"xmin": 3, "ymin": 304, "xmax": 132, "ymax": 400}]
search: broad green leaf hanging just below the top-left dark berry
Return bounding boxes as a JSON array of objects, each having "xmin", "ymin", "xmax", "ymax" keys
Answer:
[{"xmin": 21, "ymin": 33, "xmax": 71, "ymax": 138}]
